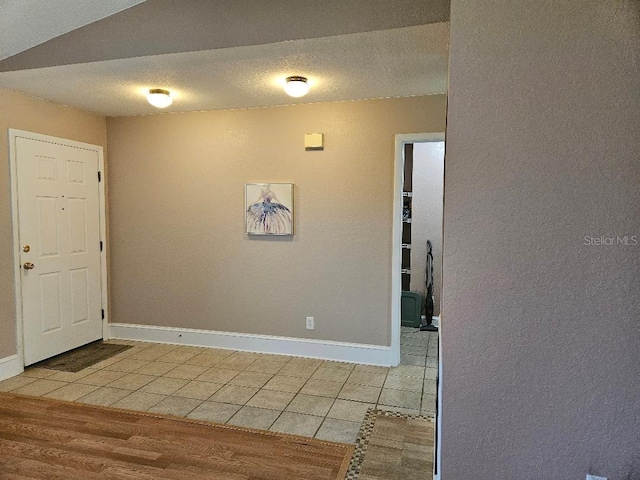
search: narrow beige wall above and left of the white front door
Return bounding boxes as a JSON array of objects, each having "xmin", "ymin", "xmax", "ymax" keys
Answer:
[{"xmin": 0, "ymin": 89, "xmax": 106, "ymax": 358}]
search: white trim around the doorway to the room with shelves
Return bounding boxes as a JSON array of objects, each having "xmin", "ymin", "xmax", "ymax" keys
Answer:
[{"xmin": 391, "ymin": 132, "xmax": 444, "ymax": 366}]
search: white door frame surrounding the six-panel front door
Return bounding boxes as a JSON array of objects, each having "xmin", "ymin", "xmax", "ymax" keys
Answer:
[{"xmin": 9, "ymin": 128, "xmax": 109, "ymax": 372}]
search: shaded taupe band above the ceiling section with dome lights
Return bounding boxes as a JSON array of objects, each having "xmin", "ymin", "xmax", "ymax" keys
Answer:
[{"xmin": 0, "ymin": 0, "xmax": 449, "ymax": 71}]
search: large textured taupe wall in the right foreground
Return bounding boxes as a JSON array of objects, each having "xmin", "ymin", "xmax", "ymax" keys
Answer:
[{"xmin": 441, "ymin": 0, "xmax": 640, "ymax": 480}]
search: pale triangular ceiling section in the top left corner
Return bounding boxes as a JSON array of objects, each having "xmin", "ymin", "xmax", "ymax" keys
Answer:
[{"xmin": 0, "ymin": 0, "xmax": 144, "ymax": 60}]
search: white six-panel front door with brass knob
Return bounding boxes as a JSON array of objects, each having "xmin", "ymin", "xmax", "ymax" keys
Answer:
[{"xmin": 15, "ymin": 136, "xmax": 102, "ymax": 365}]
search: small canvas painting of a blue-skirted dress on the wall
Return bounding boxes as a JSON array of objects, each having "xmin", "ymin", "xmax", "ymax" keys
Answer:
[{"xmin": 246, "ymin": 184, "xmax": 293, "ymax": 235}]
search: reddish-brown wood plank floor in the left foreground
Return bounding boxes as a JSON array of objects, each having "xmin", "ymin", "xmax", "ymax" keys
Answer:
[{"xmin": 0, "ymin": 393, "xmax": 353, "ymax": 480}]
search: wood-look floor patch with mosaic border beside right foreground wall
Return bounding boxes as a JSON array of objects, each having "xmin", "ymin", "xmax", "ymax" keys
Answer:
[{"xmin": 345, "ymin": 409, "xmax": 434, "ymax": 480}]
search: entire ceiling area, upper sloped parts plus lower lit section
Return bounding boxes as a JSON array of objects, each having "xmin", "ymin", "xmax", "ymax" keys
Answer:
[{"xmin": 0, "ymin": 0, "xmax": 449, "ymax": 116}]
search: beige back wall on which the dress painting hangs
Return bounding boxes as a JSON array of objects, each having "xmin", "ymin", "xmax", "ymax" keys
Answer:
[{"xmin": 107, "ymin": 96, "xmax": 445, "ymax": 345}]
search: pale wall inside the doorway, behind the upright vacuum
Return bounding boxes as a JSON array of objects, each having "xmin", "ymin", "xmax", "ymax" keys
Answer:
[{"xmin": 411, "ymin": 142, "xmax": 444, "ymax": 315}]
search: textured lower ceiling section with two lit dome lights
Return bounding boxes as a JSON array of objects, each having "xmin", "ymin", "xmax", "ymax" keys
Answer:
[{"xmin": 0, "ymin": 22, "xmax": 449, "ymax": 116}]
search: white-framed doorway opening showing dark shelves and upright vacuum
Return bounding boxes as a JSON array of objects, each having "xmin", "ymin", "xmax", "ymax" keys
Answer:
[{"xmin": 391, "ymin": 132, "xmax": 444, "ymax": 358}]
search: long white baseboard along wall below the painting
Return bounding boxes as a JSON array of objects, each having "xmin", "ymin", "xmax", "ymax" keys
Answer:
[{"xmin": 109, "ymin": 323, "xmax": 392, "ymax": 367}]
